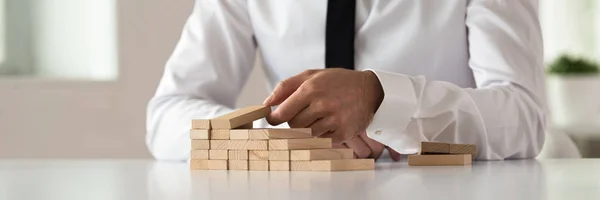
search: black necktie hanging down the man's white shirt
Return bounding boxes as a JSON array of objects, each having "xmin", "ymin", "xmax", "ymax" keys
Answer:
[{"xmin": 325, "ymin": 0, "xmax": 356, "ymax": 70}]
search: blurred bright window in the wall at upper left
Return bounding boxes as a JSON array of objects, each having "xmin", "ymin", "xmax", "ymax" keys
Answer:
[{"xmin": 0, "ymin": 0, "xmax": 118, "ymax": 80}]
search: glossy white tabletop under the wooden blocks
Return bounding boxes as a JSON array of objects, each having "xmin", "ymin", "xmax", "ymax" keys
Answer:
[{"xmin": 0, "ymin": 159, "xmax": 600, "ymax": 200}]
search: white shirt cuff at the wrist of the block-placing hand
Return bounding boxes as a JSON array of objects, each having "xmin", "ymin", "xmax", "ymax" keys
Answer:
[{"xmin": 367, "ymin": 69, "xmax": 421, "ymax": 154}]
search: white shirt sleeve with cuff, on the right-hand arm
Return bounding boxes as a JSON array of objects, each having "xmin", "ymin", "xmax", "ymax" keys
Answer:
[{"xmin": 367, "ymin": 0, "xmax": 546, "ymax": 160}]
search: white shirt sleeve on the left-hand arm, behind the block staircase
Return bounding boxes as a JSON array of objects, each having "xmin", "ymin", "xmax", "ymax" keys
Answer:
[{"xmin": 146, "ymin": 0, "xmax": 256, "ymax": 161}]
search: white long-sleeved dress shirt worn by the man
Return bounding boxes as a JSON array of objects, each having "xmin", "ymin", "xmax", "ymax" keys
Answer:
[{"xmin": 147, "ymin": 0, "xmax": 546, "ymax": 160}]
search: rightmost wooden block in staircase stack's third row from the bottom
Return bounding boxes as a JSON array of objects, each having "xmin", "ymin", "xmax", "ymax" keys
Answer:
[{"xmin": 269, "ymin": 138, "xmax": 331, "ymax": 150}]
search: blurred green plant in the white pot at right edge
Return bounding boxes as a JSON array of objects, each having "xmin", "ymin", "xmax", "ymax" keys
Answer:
[{"xmin": 547, "ymin": 55, "xmax": 599, "ymax": 75}]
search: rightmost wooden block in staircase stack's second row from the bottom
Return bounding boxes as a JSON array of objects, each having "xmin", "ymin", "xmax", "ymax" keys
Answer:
[{"xmin": 290, "ymin": 149, "xmax": 354, "ymax": 160}]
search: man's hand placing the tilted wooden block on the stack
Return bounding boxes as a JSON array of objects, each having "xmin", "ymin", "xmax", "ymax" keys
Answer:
[{"xmin": 264, "ymin": 69, "xmax": 384, "ymax": 144}]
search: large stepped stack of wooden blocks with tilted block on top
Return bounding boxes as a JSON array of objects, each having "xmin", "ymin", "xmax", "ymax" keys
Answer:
[{"xmin": 190, "ymin": 106, "xmax": 375, "ymax": 171}]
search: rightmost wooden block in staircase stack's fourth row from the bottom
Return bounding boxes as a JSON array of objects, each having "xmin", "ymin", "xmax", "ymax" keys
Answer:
[{"xmin": 248, "ymin": 128, "xmax": 313, "ymax": 140}]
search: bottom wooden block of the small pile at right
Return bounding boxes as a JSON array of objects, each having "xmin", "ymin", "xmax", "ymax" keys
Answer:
[{"xmin": 408, "ymin": 154, "xmax": 471, "ymax": 166}]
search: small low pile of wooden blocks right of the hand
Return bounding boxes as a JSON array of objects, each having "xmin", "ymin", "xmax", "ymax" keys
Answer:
[{"xmin": 408, "ymin": 142, "xmax": 477, "ymax": 166}]
